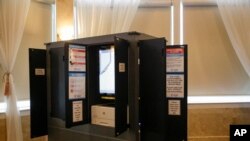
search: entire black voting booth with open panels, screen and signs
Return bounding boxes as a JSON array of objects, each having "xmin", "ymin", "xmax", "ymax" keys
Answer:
[{"xmin": 29, "ymin": 32, "xmax": 187, "ymax": 141}]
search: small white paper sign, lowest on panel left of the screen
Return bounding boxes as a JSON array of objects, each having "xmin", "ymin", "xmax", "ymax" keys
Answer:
[{"xmin": 72, "ymin": 101, "xmax": 83, "ymax": 122}]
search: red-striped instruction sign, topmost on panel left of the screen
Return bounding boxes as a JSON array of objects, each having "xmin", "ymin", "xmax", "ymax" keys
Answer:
[{"xmin": 69, "ymin": 45, "xmax": 86, "ymax": 71}]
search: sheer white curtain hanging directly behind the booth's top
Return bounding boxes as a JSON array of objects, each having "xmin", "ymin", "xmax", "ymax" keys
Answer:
[{"xmin": 76, "ymin": 0, "xmax": 140, "ymax": 38}]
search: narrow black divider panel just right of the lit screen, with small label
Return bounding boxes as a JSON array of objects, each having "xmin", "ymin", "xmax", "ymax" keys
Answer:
[{"xmin": 115, "ymin": 38, "xmax": 129, "ymax": 136}]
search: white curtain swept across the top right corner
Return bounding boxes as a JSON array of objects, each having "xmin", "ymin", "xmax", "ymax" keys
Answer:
[{"xmin": 217, "ymin": 0, "xmax": 250, "ymax": 77}]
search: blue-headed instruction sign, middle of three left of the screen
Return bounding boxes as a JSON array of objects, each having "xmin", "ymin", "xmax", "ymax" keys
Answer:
[{"xmin": 69, "ymin": 73, "xmax": 86, "ymax": 99}]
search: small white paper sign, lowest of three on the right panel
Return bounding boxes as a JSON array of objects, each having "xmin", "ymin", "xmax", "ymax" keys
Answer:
[{"xmin": 168, "ymin": 100, "xmax": 181, "ymax": 115}]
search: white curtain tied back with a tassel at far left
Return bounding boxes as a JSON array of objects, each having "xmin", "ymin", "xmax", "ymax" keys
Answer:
[{"xmin": 0, "ymin": 0, "xmax": 30, "ymax": 141}]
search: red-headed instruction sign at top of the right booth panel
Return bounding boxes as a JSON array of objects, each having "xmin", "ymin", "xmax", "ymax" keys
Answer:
[{"xmin": 166, "ymin": 48, "xmax": 184, "ymax": 72}]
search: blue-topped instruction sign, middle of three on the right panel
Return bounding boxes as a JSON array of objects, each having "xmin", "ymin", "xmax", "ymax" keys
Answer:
[{"xmin": 166, "ymin": 74, "xmax": 184, "ymax": 98}]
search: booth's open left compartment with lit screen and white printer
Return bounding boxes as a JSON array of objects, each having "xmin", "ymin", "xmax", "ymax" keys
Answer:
[{"xmin": 47, "ymin": 37, "xmax": 128, "ymax": 135}]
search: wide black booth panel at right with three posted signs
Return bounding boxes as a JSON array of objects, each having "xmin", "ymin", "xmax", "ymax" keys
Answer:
[{"xmin": 139, "ymin": 43, "xmax": 188, "ymax": 141}]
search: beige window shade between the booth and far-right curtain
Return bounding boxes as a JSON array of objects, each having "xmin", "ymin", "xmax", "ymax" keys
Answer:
[{"xmin": 183, "ymin": 6, "xmax": 250, "ymax": 96}]
